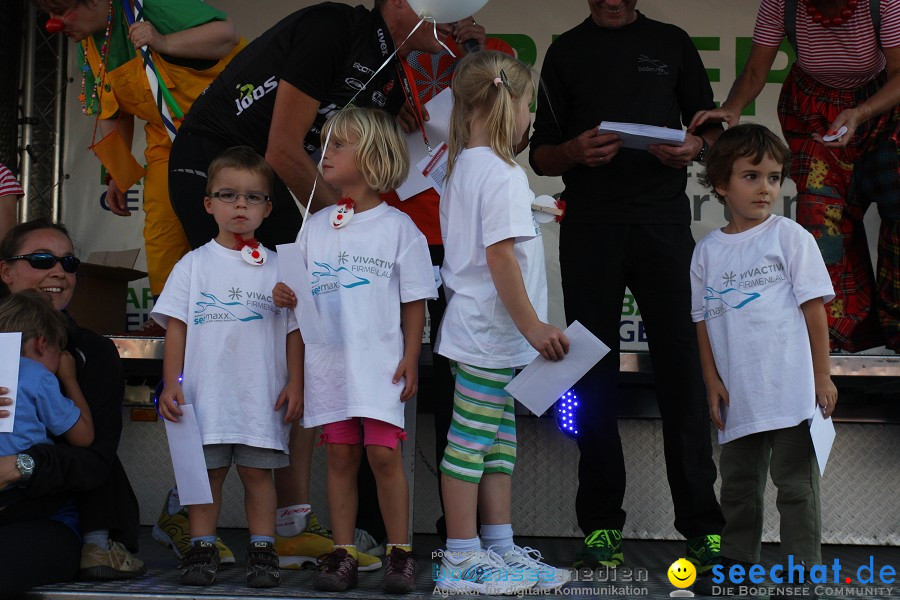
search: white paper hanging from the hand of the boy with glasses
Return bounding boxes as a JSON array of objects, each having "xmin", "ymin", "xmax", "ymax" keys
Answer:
[{"xmin": 165, "ymin": 404, "xmax": 212, "ymax": 506}]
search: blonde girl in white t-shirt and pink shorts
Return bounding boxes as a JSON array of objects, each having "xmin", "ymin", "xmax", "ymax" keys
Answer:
[{"xmin": 273, "ymin": 108, "xmax": 437, "ymax": 593}]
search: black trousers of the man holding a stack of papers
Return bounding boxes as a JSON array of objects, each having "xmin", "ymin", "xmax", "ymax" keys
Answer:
[{"xmin": 559, "ymin": 221, "xmax": 724, "ymax": 538}]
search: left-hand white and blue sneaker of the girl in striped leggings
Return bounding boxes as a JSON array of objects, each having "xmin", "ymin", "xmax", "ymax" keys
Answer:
[{"xmin": 434, "ymin": 549, "xmax": 537, "ymax": 596}]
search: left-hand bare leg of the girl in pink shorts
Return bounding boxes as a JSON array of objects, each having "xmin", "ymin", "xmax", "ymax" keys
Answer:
[{"xmin": 325, "ymin": 444, "xmax": 362, "ymax": 546}]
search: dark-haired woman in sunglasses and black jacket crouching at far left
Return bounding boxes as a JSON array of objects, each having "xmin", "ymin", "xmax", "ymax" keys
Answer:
[{"xmin": 0, "ymin": 219, "xmax": 145, "ymax": 597}]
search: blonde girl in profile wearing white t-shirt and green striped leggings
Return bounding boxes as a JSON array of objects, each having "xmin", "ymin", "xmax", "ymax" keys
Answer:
[{"xmin": 436, "ymin": 52, "xmax": 569, "ymax": 594}]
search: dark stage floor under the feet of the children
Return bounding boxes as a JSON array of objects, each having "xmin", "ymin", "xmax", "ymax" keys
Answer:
[{"xmin": 19, "ymin": 528, "xmax": 900, "ymax": 600}]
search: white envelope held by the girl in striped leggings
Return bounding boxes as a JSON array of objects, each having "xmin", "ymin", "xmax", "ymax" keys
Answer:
[{"xmin": 506, "ymin": 321, "xmax": 609, "ymax": 416}]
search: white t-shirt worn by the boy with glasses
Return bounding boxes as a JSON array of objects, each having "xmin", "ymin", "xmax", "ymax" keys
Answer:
[{"xmin": 151, "ymin": 240, "xmax": 297, "ymax": 452}]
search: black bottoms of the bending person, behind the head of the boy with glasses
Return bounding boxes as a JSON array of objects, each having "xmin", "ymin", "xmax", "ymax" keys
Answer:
[{"xmin": 169, "ymin": 132, "xmax": 307, "ymax": 250}]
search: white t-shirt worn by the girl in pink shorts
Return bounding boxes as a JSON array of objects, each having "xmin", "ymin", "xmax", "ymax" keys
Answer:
[{"xmin": 296, "ymin": 203, "xmax": 437, "ymax": 427}]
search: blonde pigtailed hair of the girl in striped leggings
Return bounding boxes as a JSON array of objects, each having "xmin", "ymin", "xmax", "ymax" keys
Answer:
[{"xmin": 447, "ymin": 51, "xmax": 534, "ymax": 178}]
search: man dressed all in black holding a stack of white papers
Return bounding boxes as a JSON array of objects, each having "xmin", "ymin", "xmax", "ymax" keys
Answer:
[{"xmin": 530, "ymin": 0, "xmax": 724, "ymax": 573}]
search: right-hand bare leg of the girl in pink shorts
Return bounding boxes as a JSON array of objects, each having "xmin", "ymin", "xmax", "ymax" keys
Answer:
[{"xmin": 366, "ymin": 445, "xmax": 409, "ymax": 544}]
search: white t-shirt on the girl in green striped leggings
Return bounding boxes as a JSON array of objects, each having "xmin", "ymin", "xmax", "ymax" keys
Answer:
[{"xmin": 436, "ymin": 147, "xmax": 547, "ymax": 369}]
